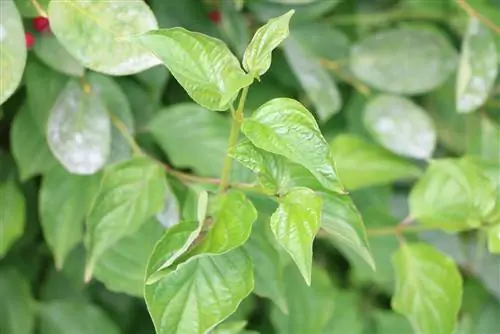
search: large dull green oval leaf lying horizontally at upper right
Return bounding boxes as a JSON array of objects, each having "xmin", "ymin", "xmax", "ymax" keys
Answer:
[{"xmin": 350, "ymin": 26, "xmax": 457, "ymax": 95}]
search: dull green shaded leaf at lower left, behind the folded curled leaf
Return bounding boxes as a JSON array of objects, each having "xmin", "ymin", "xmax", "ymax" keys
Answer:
[{"xmin": 94, "ymin": 219, "xmax": 163, "ymax": 298}]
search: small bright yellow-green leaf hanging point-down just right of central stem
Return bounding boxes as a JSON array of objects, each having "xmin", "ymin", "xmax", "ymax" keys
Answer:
[{"xmin": 271, "ymin": 188, "xmax": 322, "ymax": 285}]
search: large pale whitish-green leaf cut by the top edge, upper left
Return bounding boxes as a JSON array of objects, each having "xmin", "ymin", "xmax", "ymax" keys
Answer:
[{"xmin": 48, "ymin": 0, "xmax": 159, "ymax": 75}]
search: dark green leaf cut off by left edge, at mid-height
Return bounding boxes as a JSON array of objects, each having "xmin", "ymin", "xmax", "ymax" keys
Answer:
[{"xmin": 0, "ymin": 177, "xmax": 26, "ymax": 259}]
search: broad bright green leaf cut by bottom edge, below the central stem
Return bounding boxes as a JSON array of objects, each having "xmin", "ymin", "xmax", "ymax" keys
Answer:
[{"xmin": 145, "ymin": 249, "xmax": 253, "ymax": 334}]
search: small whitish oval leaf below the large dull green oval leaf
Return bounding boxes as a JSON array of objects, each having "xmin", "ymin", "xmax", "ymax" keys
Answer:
[{"xmin": 364, "ymin": 95, "xmax": 437, "ymax": 159}]
